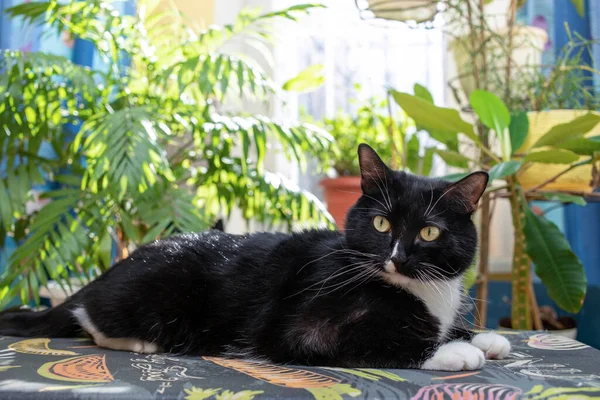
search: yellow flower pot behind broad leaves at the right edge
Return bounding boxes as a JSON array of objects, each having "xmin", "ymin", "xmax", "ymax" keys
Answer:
[{"xmin": 517, "ymin": 110, "xmax": 600, "ymax": 192}]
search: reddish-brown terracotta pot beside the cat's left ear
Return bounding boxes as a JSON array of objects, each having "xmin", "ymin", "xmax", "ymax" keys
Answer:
[{"xmin": 321, "ymin": 176, "xmax": 362, "ymax": 231}]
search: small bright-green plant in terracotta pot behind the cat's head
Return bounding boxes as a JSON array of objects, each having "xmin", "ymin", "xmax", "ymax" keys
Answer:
[{"xmin": 321, "ymin": 91, "xmax": 434, "ymax": 229}]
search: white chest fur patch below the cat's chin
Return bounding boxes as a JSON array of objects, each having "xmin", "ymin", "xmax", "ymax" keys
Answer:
[{"xmin": 404, "ymin": 278, "xmax": 462, "ymax": 340}]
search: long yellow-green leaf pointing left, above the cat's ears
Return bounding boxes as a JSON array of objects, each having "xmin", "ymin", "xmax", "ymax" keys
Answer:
[{"xmin": 390, "ymin": 89, "xmax": 479, "ymax": 144}]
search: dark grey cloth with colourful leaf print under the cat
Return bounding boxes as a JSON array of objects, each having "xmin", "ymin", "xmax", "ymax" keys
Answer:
[{"xmin": 0, "ymin": 332, "xmax": 600, "ymax": 400}]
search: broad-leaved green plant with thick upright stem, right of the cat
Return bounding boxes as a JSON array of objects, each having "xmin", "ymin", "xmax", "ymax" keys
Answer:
[{"xmin": 392, "ymin": 85, "xmax": 600, "ymax": 329}]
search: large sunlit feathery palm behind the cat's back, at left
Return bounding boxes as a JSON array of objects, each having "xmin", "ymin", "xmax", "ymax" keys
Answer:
[{"xmin": 0, "ymin": 0, "xmax": 332, "ymax": 306}]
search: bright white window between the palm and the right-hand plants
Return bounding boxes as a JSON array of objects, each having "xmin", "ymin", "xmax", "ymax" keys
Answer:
[{"xmin": 275, "ymin": 0, "xmax": 446, "ymax": 194}]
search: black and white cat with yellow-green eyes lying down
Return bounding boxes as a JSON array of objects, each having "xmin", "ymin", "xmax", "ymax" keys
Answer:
[{"xmin": 0, "ymin": 144, "xmax": 510, "ymax": 371}]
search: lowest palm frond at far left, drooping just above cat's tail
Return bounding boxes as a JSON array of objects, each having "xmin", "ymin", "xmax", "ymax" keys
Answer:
[{"xmin": 0, "ymin": 190, "xmax": 109, "ymax": 304}]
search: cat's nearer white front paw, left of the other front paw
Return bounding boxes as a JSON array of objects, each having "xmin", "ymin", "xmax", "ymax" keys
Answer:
[{"xmin": 421, "ymin": 342, "xmax": 485, "ymax": 371}]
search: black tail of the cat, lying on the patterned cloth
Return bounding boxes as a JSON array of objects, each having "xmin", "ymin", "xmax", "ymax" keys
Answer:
[{"xmin": 0, "ymin": 301, "xmax": 81, "ymax": 337}]
